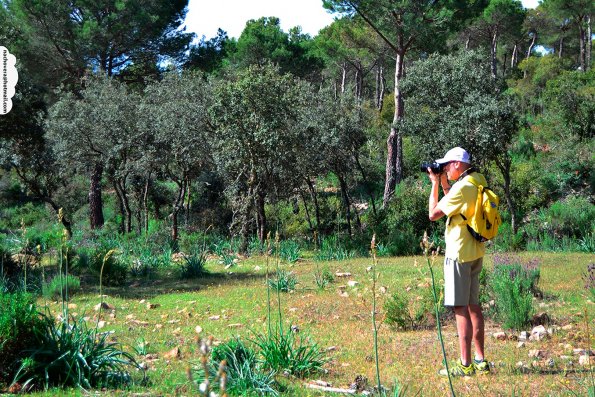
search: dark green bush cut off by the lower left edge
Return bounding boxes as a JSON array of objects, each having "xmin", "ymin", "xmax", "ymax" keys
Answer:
[{"xmin": 0, "ymin": 291, "xmax": 40, "ymax": 389}]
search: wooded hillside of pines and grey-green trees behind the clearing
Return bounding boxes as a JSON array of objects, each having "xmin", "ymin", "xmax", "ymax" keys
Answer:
[{"xmin": 0, "ymin": 0, "xmax": 595, "ymax": 255}]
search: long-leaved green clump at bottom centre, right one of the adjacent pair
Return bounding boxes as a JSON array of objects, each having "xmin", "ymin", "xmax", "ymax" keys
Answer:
[{"xmin": 255, "ymin": 328, "xmax": 327, "ymax": 378}]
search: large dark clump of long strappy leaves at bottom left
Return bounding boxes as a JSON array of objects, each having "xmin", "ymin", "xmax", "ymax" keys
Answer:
[{"xmin": 15, "ymin": 314, "xmax": 145, "ymax": 390}]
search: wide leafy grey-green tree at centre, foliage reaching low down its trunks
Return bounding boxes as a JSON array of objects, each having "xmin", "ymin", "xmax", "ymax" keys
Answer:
[{"xmin": 210, "ymin": 64, "xmax": 309, "ymax": 250}]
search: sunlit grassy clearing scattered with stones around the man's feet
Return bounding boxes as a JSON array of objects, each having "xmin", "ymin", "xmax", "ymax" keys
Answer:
[{"xmin": 25, "ymin": 253, "xmax": 595, "ymax": 396}]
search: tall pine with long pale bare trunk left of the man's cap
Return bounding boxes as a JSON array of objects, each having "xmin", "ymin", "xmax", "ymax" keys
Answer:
[{"xmin": 323, "ymin": 0, "xmax": 452, "ymax": 206}]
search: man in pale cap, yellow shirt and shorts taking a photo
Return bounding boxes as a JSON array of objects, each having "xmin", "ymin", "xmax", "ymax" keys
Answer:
[{"xmin": 428, "ymin": 147, "xmax": 490, "ymax": 376}]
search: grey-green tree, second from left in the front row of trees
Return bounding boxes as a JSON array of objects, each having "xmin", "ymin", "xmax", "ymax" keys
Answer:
[{"xmin": 137, "ymin": 73, "xmax": 212, "ymax": 241}]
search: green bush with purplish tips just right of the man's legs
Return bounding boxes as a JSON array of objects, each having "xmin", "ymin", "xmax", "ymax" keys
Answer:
[{"xmin": 490, "ymin": 255, "xmax": 540, "ymax": 330}]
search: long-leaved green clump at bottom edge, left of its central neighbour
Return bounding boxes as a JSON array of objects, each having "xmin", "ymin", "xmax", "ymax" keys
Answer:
[{"xmin": 196, "ymin": 338, "xmax": 279, "ymax": 396}]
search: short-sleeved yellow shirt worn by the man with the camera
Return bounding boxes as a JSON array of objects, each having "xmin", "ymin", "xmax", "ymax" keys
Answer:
[{"xmin": 438, "ymin": 172, "xmax": 487, "ymax": 263}]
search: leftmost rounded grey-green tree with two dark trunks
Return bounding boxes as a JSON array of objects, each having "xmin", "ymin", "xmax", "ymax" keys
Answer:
[{"xmin": 47, "ymin": 76, "xmax": 142, "ymax": 232}]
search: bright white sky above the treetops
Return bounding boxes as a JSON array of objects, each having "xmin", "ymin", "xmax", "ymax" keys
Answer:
[{"xmin": 186, "ymin": 0, "xmax": 538, "ymax": 40}]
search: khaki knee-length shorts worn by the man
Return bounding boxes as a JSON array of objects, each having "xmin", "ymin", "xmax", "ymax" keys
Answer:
[{"xmin": 444, "ymin": 258, "xmax": 483, "ymax": 306}]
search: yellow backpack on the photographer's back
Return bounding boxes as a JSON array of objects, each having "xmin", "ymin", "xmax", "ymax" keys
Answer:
[{"xmin": 466, "ymin": 175, "xmax": 502, "ymax": 242}]
